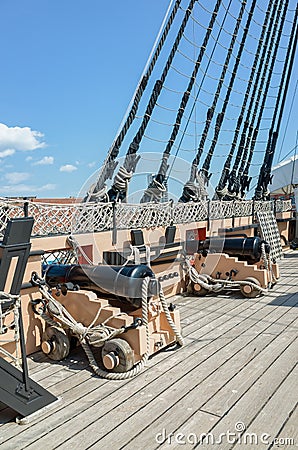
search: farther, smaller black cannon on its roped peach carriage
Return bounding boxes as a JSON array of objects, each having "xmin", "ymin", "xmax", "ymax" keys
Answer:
[{"xmin": 187, "ymin": 236, "xmax": 279, "ymax": 298}]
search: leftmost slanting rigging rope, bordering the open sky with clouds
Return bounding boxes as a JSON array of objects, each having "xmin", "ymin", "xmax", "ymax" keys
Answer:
[{"xmin": 84, "ymin": 0, "xmax": 182, "ymax": 201}]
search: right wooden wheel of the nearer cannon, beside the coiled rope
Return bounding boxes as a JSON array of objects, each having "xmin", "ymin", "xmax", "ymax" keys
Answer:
[{"xmin": 101, "ymin": 339, "xmax": 134, "ymax": 372}]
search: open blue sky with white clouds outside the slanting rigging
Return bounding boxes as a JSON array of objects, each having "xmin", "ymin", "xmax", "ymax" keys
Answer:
[{"xmin": 0, "ymin": 0, "xmax": 298, "ymax": 197}]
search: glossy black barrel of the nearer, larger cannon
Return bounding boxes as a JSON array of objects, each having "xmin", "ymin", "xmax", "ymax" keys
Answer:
[{"xmin": 44, "ymin": 264, "xmax": 160, "ymax": 308}]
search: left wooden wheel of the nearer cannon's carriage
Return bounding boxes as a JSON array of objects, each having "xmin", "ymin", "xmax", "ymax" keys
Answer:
[{"xmin": 41, "ymin": 326, "xmax": 70, "ymax": 361}]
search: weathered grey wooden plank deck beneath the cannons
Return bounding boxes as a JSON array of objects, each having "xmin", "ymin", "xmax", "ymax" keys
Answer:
[{"xmin": 0, "ymin": 251, "xmax": 298, "ymax": 450}]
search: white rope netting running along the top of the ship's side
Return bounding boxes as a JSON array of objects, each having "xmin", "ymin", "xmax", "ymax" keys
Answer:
[{"xmin": 0, "ymin": 199, "xmax": 292, "ymax": 238}]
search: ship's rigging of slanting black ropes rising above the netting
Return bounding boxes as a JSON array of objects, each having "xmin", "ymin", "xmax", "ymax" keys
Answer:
[{"xmin": 85, "ymin": 0, "xmax": 298, "ymax": 203}]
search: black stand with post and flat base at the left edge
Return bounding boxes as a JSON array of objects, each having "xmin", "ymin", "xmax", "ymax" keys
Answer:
[{"xmin": 0, "ymin": 217, "xmax": 58, "ymax": 422}]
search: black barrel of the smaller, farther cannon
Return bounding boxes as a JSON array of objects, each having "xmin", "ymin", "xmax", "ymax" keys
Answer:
[{"xmin": 187, "ymin": 236, "xmax": 270, "ymax": 261}]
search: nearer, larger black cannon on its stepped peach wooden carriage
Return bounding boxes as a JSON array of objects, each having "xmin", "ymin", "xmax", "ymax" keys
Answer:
[{"xmin": 42, "ymin": 264, "xmax": 180, "ymax": 377}]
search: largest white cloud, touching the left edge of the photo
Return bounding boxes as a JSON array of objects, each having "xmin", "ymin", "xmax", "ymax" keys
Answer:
[{"xmin": 0, "ymin": 123, "xmax": 46, "ymax": 151}]
